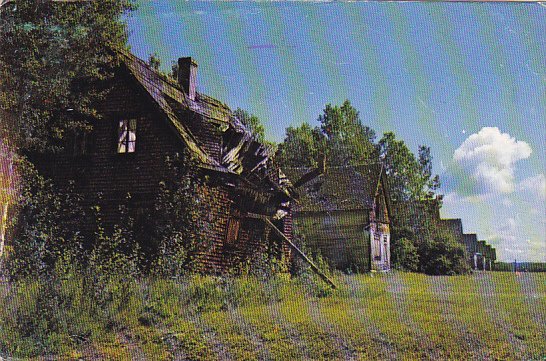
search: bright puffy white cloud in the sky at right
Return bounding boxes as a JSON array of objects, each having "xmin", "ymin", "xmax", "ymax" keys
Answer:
[{"xmin": 453, "ymin": 127, "xmax": 532, "ymax": 193}]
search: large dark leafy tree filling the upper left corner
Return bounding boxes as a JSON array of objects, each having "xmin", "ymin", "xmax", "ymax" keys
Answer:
[{"xmin": 0, "ymin": 0, "xmax": 132, "ymax": 152}]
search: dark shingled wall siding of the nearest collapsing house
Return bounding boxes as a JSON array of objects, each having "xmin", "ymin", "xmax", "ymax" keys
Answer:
[{"xmin": 31, "ymin": 65, "xmax": 291, "ymax": 273}]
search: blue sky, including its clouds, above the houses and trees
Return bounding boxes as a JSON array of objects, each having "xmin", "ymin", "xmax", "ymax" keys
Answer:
[{"xmin": 128, "ymin": 0, "xmax": 546, "ymax": 262}]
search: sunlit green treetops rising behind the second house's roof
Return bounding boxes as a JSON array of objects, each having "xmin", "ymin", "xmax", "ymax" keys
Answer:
[{"xmin": 277, "ymin": 100, "xmax": 440, "ymax": 202}]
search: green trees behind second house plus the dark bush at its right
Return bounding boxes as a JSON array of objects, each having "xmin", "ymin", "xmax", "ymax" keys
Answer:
[{"xmin": 277, "ymin": 100, "xmax": 468, "ymax": 274}]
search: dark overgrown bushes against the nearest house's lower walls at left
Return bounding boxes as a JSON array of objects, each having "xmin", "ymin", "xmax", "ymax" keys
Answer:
[{"xmin": 6, "ymin": 150, "xmax": 207, "ymax": 279}]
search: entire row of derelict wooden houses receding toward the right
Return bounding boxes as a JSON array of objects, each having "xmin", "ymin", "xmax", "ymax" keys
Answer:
[{"xmin": 0, "ymin": 51, "xmax": 496, "ymax": 272}]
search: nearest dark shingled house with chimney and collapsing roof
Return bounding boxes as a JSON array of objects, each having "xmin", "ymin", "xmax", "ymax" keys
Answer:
[{"xmin": 28, "ymin": 52, "xmax": 292, "ymax": 272}]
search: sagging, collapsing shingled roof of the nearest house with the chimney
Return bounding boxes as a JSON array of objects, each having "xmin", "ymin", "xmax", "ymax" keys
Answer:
[{"xmin": 119, "ymin": 51, "xmax": 289, "ymax": 195}]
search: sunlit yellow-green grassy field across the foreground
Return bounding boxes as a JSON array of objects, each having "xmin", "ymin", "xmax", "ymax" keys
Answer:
[{"xmin": 0, "ymin": 272, "xmax": 546, "ymax": 360}]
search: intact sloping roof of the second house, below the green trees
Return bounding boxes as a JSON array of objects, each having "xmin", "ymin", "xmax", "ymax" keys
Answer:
[{"xmin": 285, "ymin": 163, "xmax": 384, "ymax": 212}]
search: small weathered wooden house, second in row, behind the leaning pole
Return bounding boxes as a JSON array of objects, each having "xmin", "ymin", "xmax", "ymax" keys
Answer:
[{"xmin": 285, "ymin": 164, "xmax": 390, "ymax": 271}]
